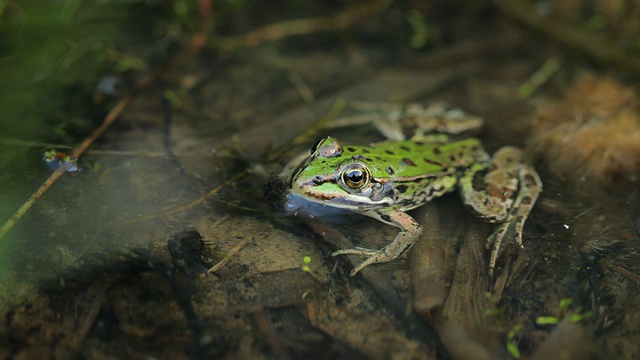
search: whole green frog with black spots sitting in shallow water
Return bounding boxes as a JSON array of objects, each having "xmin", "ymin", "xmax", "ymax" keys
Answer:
[{"xmin": 290, "ymin": 102, "xmax": 542, "ymax": 276}]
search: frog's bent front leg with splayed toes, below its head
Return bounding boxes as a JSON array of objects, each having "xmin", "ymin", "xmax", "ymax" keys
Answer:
[{"xmin": 331, "ymin": 209, "xmax": 422, "ymax": 276}]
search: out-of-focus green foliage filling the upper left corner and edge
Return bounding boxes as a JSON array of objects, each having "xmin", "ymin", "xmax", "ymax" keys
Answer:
[{"xmin": 0, "ymin": 0, "xmax": 126, "ymax": 252}]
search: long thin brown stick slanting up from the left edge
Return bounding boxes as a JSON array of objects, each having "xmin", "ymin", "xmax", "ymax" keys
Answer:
[{"xmin": 0, "ymin": 16, "xmax": 209, "ymax": 240}]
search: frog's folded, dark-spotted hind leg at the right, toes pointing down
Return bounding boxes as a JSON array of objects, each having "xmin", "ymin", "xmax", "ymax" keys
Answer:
[{"xmin": 460, "ymin": 146, "xmax": 542, "ymax": 274}]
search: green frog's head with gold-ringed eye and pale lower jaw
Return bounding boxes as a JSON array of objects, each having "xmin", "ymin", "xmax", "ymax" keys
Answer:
[{"xmin": 291, "ymin": 137, "xmax": 393, "ymax": 210}]
